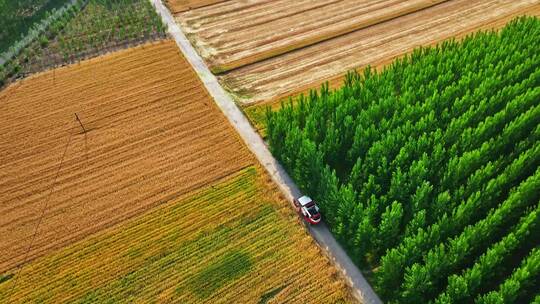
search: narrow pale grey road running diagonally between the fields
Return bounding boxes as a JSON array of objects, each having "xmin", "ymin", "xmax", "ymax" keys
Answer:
[{"xmin": 149, "ymin": 0, "xmax": 382, "ymax": 304}]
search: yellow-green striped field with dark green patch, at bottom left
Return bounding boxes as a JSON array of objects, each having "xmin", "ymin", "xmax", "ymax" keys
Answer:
[{"xmin": 0, "ymin": 167, "xmax": 351, "ymax": 303}]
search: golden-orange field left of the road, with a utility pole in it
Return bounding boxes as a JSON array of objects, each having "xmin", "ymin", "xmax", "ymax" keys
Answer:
[{"xmin": 0, "ymin": 41, "xmax": 253, "ymax": 272}]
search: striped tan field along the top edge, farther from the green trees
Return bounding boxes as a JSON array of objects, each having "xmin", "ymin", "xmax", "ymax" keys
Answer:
[{"xmin": 177, "ymin": 0, "xmax": 445, "ymax": 73}]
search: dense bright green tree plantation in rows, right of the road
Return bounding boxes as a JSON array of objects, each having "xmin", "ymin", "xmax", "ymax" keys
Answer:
[{"xmin": 264, "ymin": 18, "xmax": 540, "ymax": 303}]
